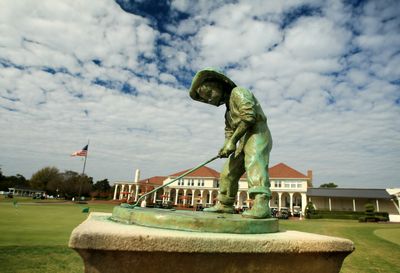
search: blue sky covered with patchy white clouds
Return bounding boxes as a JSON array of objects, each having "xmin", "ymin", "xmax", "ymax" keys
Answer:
[{"xmin": 0, "ymin": 0, "xmax": 400, "ymax": 188}]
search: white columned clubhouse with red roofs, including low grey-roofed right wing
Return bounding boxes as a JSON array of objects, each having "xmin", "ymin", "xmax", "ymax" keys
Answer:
[{"xmin": 113, "ymin": 163, "xmax": 400, "ymax": 218}]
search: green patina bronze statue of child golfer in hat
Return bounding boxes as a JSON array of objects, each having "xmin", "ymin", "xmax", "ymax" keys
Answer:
[{"xmin": 189, "ymin": 68, "xmax": 272, "ymax": 219}]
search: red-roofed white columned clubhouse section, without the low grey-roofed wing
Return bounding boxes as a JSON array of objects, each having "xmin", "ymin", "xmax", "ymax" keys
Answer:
[{"xmin": 114, "ymin": 163, "xmax": 312, "ymax": 211}]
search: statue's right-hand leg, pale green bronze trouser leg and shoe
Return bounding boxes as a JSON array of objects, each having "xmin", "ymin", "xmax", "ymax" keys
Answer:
[{"xmin": 242, "ymin": 131, "xmax": 272, "ymax": 218}]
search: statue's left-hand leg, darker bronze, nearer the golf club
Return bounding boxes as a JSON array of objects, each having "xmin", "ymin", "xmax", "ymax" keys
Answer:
[{"xmin": 204, "ymin": 153, "xmax": 245, "ymax": 213}]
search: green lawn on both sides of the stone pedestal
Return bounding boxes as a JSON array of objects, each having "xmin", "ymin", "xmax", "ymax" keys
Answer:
[{"xmin": 0, "ymin": 199, "xmax": 400, "ymax": 273}]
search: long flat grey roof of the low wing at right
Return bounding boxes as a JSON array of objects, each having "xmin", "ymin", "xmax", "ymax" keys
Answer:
[{"xmin": 307, "ymin": 188, "xmax": 391, "ymax": 199}]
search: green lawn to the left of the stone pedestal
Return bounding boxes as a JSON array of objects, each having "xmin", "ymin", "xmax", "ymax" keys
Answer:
[{"xmin": 0, "ymin": 198, "xmax": 115, "ymax": 273}]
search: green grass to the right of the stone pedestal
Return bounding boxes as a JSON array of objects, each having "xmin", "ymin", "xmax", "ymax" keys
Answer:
[{"xmin": 280, "ymin": 219, "xmax": 400, "ymax": 273}]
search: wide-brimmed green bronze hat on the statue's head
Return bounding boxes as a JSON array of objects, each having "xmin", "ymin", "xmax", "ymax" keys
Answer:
[{"xmin": 189, "ymin": 68, "xmax": 236, "ymax": 104}]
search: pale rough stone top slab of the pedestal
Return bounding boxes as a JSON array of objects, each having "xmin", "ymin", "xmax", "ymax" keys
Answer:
[{"xmin": 69, "ymin": 213, "xmax": 354, "ymax": 253}]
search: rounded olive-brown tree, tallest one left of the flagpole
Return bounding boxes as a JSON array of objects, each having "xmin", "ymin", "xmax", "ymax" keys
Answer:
[{"xmin": 30, "ymin": 167, "xmax": 62, "ymax": 191}]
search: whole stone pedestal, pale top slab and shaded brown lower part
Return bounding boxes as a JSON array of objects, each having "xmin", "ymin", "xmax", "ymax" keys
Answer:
[{"xmin": 69, "ymin": 213, "xmax": 354, "ymax": 273}]
